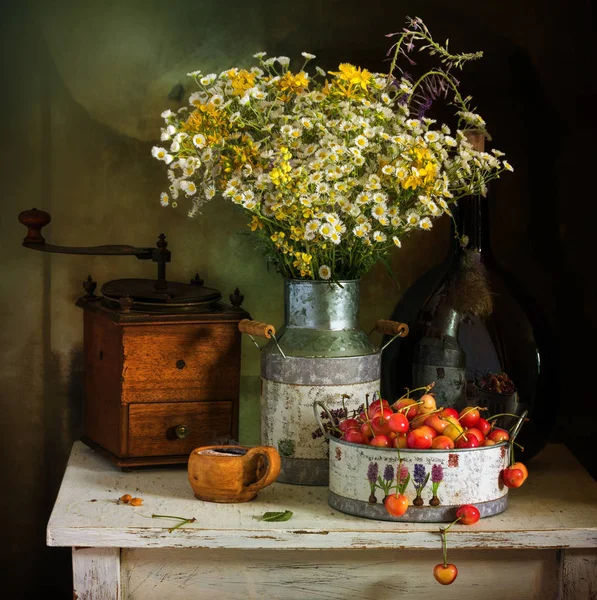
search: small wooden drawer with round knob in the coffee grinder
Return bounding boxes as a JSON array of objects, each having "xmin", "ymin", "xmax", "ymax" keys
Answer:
[{"xmin": 127, "ymin": 401, "xmax": 232, "ymax": 456}]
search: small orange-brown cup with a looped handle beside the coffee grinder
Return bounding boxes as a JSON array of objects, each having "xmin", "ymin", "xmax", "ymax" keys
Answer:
[{"xmin": 188, "ymin": 446, "xmax": 280, "ymax": 502}]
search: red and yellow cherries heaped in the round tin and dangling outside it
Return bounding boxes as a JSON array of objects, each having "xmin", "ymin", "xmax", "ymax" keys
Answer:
[{"xmin": 330, "ymin": 384, "xmax": 528, "ymax": 585}]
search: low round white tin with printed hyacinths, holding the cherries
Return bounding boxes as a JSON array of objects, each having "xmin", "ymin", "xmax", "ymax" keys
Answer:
[{"xmin": 313, "ymin": 401, "xmax": 524, "ymax": 523}]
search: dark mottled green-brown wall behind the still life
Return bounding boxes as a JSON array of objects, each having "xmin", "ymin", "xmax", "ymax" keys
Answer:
[{"xmin": 0, "ymin": 0, "xmax": 596, "ymax": 598}]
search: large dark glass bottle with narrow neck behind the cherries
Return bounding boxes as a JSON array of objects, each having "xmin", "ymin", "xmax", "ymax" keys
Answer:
[{"xmin": 382, "ymin": 192, "xmax": 559, "ymax": 460}]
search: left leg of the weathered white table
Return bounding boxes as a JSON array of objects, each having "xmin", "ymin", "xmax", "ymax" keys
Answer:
[{"xmin": 73, "ymin": 548, "xmax": 121, "ymax": 600}]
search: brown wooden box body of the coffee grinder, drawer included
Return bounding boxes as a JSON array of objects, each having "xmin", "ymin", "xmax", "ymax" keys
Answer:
[{"xmin": 77, "ymin": 298, "xmax": 248, "ymax": 467}]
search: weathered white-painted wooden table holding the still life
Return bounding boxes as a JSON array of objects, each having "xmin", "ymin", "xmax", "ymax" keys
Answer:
[{"xmin": 47, "ymin": 442, "xmax": 597, "ymax": 600}]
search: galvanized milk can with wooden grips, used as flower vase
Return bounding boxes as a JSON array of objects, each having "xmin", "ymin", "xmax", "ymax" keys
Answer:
[{"xmin": 239, "ymin": 279, "xmax": 408, "ymax": 485}]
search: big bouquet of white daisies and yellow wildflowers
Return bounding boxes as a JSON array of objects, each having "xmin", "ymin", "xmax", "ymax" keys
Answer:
[{"xmin": 152, "ymin": 19, "xmax": 511, "ymax": 281}]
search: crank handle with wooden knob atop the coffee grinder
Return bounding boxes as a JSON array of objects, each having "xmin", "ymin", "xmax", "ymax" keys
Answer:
[{"xmin": 19, "ymin": 208, "xmax": 155, "ymax": 260}]
